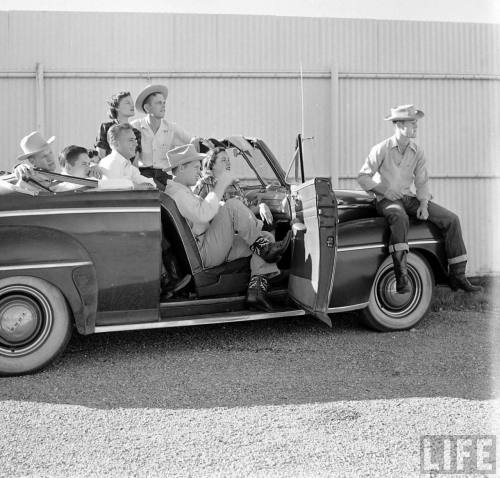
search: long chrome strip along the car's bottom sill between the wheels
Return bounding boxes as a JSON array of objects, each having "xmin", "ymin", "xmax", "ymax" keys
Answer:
[{"xmin": 94, "ymin": 309, "xmax": 306, "ymax": 334}]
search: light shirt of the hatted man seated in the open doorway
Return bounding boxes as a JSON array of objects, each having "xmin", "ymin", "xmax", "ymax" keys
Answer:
[{"xmin": 165, "ymin": 181, "xmax": 219, "ymax": 237}]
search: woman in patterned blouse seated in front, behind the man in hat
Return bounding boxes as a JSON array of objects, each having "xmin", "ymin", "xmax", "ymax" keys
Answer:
[{"xmin": 193, "ymin": 146, "xmax": 273, "ymax": 226}]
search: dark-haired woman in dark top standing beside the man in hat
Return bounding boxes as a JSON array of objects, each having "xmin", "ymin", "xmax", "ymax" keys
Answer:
[{"xmin": 95, "ymin": 91, "xmax": 142, "ymax": 162}]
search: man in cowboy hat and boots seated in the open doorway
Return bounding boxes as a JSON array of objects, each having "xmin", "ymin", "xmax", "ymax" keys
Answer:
[{"xmin": 165, "ymin": 144, "xmax": 290, "ymax": 311}]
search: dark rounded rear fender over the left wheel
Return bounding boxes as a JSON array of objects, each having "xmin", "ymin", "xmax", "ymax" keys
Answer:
[{"xmin": 0, "ymin": 225, "xmax": 98, "ymax": 334}]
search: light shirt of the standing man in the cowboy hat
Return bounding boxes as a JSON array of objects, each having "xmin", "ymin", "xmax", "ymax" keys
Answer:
[{"xmin": 130, "ymin": 116, "xmax": 193, "ymax": 169}]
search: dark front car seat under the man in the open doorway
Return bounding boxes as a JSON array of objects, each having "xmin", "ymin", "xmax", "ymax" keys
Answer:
[{"xmin": 160, "ymin": 194, "xmax": 250, "ymax": 297}]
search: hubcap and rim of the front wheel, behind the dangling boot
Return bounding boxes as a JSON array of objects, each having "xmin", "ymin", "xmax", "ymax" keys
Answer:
[{"xmin": 375, "ymin": 264, "xmax": 422, "ymax": 318}]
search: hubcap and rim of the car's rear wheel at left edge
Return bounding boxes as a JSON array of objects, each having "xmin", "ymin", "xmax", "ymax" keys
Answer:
[{"xmin": 0, "ymin": 285, "xmax": 52, "ymax": 356}]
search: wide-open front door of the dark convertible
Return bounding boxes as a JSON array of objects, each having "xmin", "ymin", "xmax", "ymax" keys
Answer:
[{"xmin": 288, "ymin": 178, "xmax": 337, "ymax": 325}]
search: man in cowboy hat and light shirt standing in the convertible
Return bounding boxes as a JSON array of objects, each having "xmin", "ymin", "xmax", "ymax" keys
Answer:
[{"xmin": 131, "ymin": 85, "xmax": 199, "ymax": 190}]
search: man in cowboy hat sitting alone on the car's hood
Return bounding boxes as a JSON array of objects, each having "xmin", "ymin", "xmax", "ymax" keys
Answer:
[{"xmin": 358, "ymin": 105, "xmax": 481, "ymax": 294}]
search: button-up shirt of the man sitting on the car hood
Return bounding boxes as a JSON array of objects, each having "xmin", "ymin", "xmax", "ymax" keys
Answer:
[{"xmin": 358, "ymin": 136, "xmax": 432, "ymax": 201}]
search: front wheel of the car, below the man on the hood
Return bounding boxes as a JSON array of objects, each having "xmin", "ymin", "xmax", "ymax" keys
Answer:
[{"xmin": 362, "ymin": 252, "xmax": 434, "ymax": 332}]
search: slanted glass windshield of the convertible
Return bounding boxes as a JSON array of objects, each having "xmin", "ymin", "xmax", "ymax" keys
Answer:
[{"xmin": 227, "ymin": 136, "xmax": 281, "ymax": 187}]
